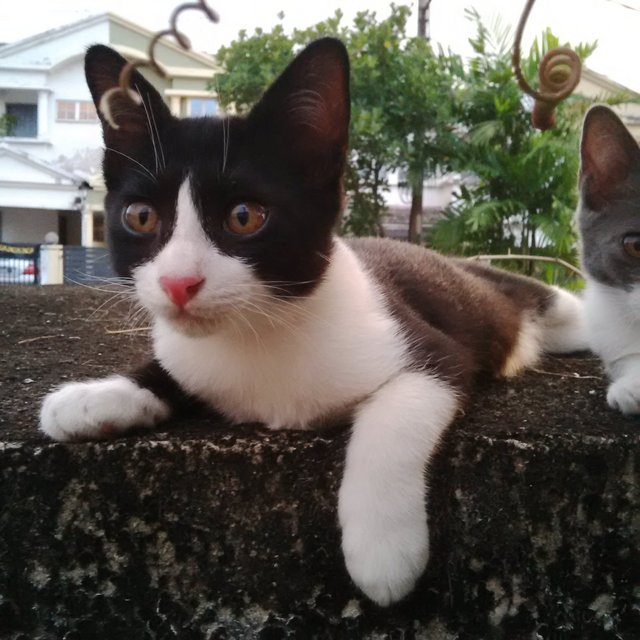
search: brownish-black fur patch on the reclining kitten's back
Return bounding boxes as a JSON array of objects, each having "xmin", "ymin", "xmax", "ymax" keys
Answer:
[{"xmin": 350, "ymin": 238, "xmax": 553, "ymax": 391}]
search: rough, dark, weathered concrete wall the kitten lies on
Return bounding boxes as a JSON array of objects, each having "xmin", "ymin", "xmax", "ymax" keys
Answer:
[{"xmin": 0, "ymin": 286, "xmax": 640, "ymax": 640}]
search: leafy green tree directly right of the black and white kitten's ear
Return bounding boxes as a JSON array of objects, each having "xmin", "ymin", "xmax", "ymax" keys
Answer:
[{"xmin": 348, "ymin": 5, "xmax": 462, "ymax": 241}]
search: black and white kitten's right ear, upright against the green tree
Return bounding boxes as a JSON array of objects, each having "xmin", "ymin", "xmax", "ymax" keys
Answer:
[{"xmin": 249, "ymin": 38, "xmax": 350, "ymax": 182}]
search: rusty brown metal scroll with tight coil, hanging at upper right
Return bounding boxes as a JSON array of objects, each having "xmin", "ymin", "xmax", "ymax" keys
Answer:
[{"xmin": 511, "ymin": 0, "xmax": 582, "ymax": 131}]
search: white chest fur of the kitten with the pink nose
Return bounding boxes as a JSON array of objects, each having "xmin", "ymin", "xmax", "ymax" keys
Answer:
[{"xmin": 154, "ymin": 240, "xmax": 407, "ymax": 428}]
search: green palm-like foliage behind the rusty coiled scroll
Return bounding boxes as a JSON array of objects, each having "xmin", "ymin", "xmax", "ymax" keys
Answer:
[{"xmin": 432, "ymin": 12, "xmax": 595, "ymax": 279}]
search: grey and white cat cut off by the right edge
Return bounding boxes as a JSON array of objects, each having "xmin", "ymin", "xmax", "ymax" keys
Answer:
[{"xmin": 577, "ymin": 105, "xmax": 640, "ymax": 414}]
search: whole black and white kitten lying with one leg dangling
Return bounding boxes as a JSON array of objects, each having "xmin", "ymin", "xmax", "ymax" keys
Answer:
[{"xmin": 41, "ymin": 39, "xmax": 584, "ymax": 605}]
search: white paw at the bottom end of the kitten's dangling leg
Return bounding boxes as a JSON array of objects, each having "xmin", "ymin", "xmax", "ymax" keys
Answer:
[{"xmin": 342, "ymin": 513, "xmax": 429, "ymax": 607}]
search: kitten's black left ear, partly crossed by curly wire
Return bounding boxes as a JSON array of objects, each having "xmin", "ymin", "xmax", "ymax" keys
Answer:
[{"xmin": 84, "ymin": 45, "xmax": 172, "ymax": 147}]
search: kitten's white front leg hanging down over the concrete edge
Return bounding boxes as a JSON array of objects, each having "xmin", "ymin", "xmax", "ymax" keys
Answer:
[{"xmin": 338, "ymin": 372, "xmax": 459, "ymax": 606}]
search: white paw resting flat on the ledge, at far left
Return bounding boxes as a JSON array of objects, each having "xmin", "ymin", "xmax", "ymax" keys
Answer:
[{"xmin": 40, "ymin": 376, "xmax": 169, "ymax": 440}]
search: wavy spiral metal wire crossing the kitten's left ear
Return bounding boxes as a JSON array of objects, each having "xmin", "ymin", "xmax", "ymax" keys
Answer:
[{"xmin": 99, "ymin": 0, "xmax": 220, "ymax": 129}]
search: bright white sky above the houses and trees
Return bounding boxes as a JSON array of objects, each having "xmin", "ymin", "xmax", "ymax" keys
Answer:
[{"xmin": 0, "ymin": 0, "xmax": 640, "ymax": 92}]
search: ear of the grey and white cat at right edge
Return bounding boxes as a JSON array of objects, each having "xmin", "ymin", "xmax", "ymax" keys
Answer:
[{"xmin": 580, "ymin": 105, "xmax": 640, "ymax": 211}]
